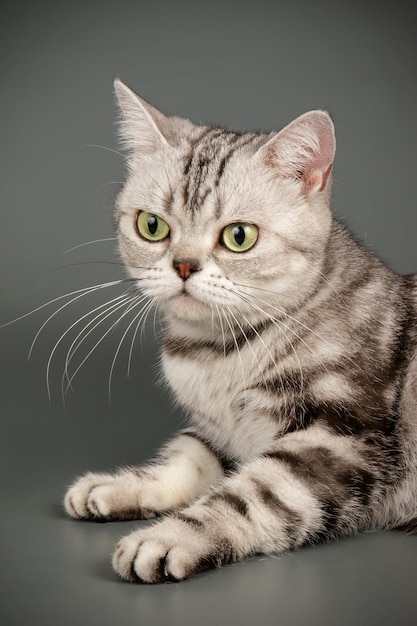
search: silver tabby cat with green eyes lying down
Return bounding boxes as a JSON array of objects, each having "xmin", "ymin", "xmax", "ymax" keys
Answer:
[{"xmin": 65, "ymin": 80, "xmax": 417, "ymax": 583}]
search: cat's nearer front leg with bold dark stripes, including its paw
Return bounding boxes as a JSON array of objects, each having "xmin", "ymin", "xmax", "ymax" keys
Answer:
[{"xmin": 113, "ymin": 433, "xmax": 372, "ymax": 583}]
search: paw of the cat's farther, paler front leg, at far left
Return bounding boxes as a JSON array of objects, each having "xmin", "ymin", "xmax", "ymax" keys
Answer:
[{"xmin": 64, "ymin": 473, "xmax": 155, "ymax": 520}]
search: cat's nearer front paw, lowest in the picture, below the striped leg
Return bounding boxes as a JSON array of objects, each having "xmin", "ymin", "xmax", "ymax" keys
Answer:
[{"xmin": 113, "ymin": 518, "xmax": 232, "ymax": 583}]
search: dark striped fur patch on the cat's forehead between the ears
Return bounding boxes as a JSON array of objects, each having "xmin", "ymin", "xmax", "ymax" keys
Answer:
[{"xmin": 182, "ymin": 128, "xmax": 257, "ymax": 216}]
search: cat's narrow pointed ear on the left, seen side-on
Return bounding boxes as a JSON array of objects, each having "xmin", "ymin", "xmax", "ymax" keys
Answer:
[{"xmin": 114, "ymin": 78, "xmax": 168, "ymax": 154}]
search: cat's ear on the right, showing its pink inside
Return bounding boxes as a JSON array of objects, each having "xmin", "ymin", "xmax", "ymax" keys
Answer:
[{"xmin": 260, "ymin": 111, "xmax": 336, "ymax": 193}]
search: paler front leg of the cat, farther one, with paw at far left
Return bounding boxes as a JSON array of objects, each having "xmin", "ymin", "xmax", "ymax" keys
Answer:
[{"xmin": 64, "ymin": 434, "xmax": 224, "ymax": 520}]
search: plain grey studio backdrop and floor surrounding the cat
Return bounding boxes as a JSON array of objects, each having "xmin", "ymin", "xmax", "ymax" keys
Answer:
[{"xmin": 0, "ymin": 0, "xmax": 417, "ymax": 626}]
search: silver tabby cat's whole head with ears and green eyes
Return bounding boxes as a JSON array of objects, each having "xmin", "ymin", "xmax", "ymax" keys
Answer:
[{"xmin": 115, "ymin": 80, "xmax": 335, "ymax": 334}]
